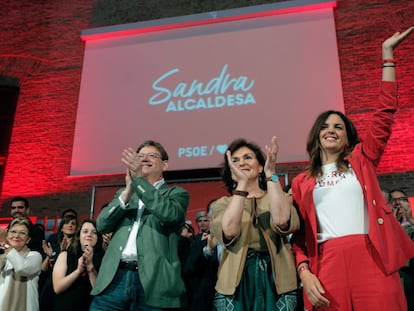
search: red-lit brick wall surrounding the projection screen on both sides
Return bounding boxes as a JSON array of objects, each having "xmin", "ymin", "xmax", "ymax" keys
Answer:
[{"xmin": 0, "ymin": 0, "xmax": 414, "ymax": 216}]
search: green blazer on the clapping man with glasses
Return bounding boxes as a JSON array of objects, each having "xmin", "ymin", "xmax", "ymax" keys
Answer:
[{"xmin": 92, "ymin": 177, "xmax": 189, "ymax": 308}]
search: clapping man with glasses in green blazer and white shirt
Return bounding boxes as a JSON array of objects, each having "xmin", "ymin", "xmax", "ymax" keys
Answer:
[{"xmin": 90, "ymin": 140, "xmax": 189, "ymax": 311}]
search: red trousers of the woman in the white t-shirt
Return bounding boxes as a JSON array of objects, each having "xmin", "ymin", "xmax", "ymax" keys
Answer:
[{"xmin": 315, "ymin": 234, "xmax": 406, "ymax": 311}]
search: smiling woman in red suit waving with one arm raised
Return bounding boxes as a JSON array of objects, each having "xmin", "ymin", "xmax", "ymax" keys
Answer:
[{"xmin": 292, "ymin": 27, "xmax": 414, "ymax": 311}]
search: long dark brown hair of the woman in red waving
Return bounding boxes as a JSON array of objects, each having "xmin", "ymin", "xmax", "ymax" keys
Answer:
[{"xmin": 306, "ymin": 110, "xmax": 359, "ymax": 177}]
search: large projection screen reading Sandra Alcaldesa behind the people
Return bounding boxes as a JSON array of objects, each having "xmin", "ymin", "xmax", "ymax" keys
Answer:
[{"xmin": 70, "ymin": 1, "xmax": 343, "ymax": 176}]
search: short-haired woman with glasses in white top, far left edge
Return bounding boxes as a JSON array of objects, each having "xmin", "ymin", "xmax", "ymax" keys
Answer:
[{"xmin": 0, "ymin": 218, "xmax": 42, "ymax": 311}]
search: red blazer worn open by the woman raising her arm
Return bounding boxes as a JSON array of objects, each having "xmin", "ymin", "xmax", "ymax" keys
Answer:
[{"xmin": 292, "ymin": 82, "xmax": 414, "ymax": 286}]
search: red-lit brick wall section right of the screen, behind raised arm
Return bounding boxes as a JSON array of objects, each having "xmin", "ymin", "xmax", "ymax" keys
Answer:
[{"xmin": 335, "ymin": 0, "xmax": 414, "ymax": 196}]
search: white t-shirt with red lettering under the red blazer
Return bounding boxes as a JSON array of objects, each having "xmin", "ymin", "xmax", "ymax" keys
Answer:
[{"xmin": 313, "ymin": 163, "xmax": 369, "ymax": 243}]
